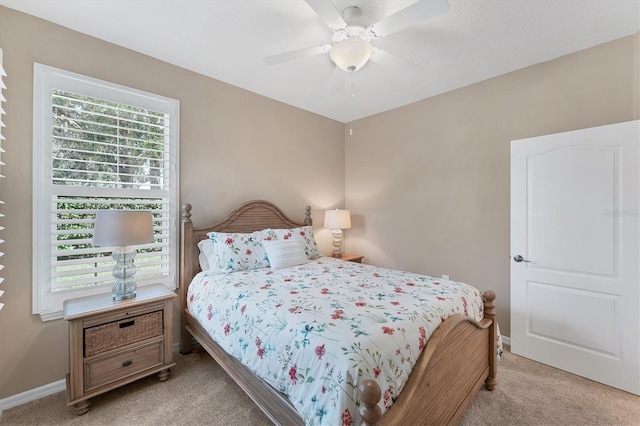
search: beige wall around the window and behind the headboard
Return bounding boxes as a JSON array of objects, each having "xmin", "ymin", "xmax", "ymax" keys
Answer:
[{"xmin": 0, "ymin": 6, "xmax": 344, "ymax": 399}]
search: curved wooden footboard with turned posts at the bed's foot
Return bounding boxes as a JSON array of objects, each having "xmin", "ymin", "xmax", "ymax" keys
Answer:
[{"xmin": 360, "ymin": 291, "xmax": 498, "ymax": 425}]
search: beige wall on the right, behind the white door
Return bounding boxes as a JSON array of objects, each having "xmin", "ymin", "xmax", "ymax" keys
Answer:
[{"xmin": 345, "ymin": 34, "xmax": 640, "ymax": 335}]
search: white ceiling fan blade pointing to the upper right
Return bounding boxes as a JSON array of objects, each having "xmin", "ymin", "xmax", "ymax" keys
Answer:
[{"xmin": 367, "ymin": 0, "xmax": 449, "ymax": 38}]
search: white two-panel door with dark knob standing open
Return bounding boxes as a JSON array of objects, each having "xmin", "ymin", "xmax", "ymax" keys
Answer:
[{"xmin": 511, "ymin": 121, "xmax": 640, "ymax": 395}]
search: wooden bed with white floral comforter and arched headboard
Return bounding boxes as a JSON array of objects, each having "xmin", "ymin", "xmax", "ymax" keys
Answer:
[{"xmin": 180, "ymin": 201, "xmax": 499, "ymax": 425}]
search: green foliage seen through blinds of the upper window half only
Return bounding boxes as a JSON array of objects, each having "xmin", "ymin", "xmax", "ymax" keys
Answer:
[{"xmin": 52, "ymin": 90, "xmax": 165, "ymax": 188}]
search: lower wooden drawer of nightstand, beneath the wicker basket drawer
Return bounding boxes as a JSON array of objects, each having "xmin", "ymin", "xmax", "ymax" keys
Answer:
[{"xmin": 84, "ymin": 339, "xmax": 164, "ymax": 392}]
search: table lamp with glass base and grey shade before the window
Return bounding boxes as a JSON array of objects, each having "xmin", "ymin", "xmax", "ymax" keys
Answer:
[{"xmin": 93, "ymin": 210, "xmax": 154, "ymax": 300}]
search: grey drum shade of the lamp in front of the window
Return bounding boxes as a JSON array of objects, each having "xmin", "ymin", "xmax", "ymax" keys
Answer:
[{"xmin": 93, "ymin": 210, "xmax": 154, "ymax": 247}]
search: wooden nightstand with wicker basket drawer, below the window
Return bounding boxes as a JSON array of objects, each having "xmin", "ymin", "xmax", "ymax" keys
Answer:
[{"xmin": 64, "ymin": 284, "xmax": 176, "ymax": 415}]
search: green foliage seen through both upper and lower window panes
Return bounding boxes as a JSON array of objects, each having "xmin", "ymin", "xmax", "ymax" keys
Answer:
[{"xmin": 51, "ymin": 90, "xmax": 166, "ymax": 288}]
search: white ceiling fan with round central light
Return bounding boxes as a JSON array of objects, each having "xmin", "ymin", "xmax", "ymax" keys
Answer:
[{"xmin": 264, "ymin": 0, "xmax": 449, "ymax": 86}]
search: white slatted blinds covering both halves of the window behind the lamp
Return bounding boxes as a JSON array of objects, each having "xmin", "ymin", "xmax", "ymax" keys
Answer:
[{"xmin": 51, "ymin": 90, "xmax": 171, "ymax": 290}]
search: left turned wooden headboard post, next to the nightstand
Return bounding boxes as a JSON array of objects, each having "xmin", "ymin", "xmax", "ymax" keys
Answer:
[{"xmin": 179, "ymin": 204, "xmax": 193, "ymax": 354}]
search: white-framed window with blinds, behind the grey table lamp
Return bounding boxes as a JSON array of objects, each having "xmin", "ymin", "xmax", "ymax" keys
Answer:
[{"xmin": 33, "ymin": 64, "xmax": 179, "ymax": 320}]
